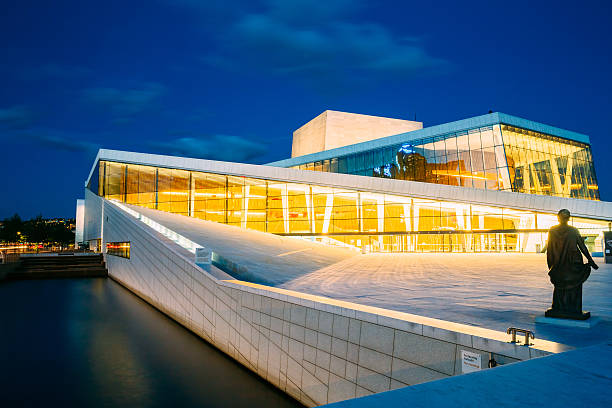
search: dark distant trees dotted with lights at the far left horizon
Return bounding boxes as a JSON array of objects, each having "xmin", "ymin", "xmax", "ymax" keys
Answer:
[{"xmin": 0, "ymin": 214, "xmax": 74, "ymax": 246}]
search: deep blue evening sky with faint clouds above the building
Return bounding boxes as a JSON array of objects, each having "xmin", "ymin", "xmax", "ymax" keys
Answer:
[{"xmin": 0, "ymin": 0, "xmax": 612, "ymax": 218}]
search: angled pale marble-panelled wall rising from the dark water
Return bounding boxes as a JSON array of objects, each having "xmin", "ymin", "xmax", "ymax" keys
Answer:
[{"xmin": 101, "ymin": 201, "xmax": 559, "ymax": 406}]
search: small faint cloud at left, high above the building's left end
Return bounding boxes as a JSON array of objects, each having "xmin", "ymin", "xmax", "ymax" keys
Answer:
[{"xmin": 83, "ymin": 83, "xmax": 165, "ymax": 119}]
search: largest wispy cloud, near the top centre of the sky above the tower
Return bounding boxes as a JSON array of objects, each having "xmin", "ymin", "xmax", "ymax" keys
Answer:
[{"xmin": 235, "ymin": 15, "xmax": 444, "ymax": 74}]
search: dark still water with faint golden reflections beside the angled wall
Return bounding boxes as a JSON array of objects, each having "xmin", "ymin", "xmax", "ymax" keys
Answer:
[{"xmin": 0, "ymin": 279, "xmax": 300, "ymax": 408}]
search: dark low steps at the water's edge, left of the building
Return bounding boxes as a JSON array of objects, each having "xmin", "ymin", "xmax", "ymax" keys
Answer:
[{"xmin": 6, "ymin": 253, "xmax": 108, "ymax": 279}]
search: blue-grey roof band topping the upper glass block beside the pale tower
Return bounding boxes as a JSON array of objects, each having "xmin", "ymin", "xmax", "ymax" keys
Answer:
[{"xmin": 267, "ymin": 112, "xmax": 591, "ymax": 167}]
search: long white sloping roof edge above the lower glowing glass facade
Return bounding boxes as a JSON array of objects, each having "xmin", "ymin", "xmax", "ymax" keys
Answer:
[{"xmin": 85, "ymin": 149, "xmax": 612, "ymax": 221}]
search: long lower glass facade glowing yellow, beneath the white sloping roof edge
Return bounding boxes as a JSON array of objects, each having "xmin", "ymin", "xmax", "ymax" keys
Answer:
[{"xmin": 90, "ymin": 161, "xmax": 608, "ymax": 252}]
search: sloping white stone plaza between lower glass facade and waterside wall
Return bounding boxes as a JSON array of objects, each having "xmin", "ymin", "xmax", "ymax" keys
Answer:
[{"xmin": 117, "ymin": 206, "xmax": 612, "ymax": 345}]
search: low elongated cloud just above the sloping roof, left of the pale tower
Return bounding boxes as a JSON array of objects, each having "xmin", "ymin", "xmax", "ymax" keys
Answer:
[{"xmin": 149, "ymin": 135, "xmax": 268, "ymax": 162}]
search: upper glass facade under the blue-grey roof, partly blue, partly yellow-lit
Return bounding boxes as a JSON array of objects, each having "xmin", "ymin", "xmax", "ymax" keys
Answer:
[{"xmin": 295, "ymin": 125, "xmax": 599, "ymax": 200}]
